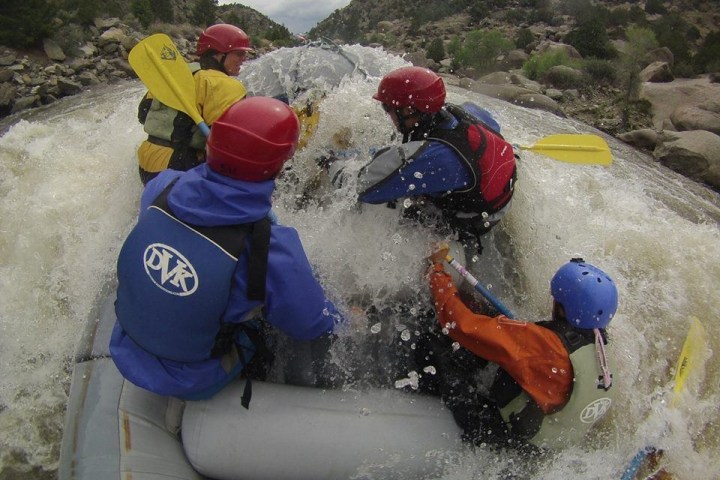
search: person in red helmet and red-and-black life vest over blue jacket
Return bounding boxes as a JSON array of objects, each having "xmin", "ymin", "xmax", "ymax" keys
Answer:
[{"xmin": 344, "ymin": 67, "xmax": 517, "ymax": 255}]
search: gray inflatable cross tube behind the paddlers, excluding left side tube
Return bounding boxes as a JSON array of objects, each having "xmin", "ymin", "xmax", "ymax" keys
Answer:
[{"xmin": 182, "ymin": 376, "xmax": 460, "ymax": 480}]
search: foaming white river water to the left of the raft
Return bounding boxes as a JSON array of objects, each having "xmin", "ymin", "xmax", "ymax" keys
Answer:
[{"xmin": 0, "ymin": 84, "xmax": 143, "ymax": 478}]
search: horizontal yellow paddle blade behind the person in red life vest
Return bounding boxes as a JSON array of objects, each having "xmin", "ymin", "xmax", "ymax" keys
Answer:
[{"xmin": 520, "ymin": 134, "xmax": 612, "ymax": 166}]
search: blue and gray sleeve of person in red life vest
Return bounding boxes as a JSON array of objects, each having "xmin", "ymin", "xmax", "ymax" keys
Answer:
[{"xmin": 358, "ymin": 141, "xmax": 472, "ymax": 204}]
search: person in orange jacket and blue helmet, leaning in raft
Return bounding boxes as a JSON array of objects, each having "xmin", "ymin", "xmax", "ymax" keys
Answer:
[{"xmin": 416, "ymin": 250, "xmax": 618, "ymax": 449}]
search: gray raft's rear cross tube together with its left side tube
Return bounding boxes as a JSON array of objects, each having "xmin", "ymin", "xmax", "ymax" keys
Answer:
[{"xmin": 58, "ymin": 358, "xmax": 462, "ymax": 480}]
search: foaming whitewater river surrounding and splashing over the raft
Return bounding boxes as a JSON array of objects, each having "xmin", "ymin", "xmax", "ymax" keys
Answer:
[{"xmin": 0, "ymin": 47, "xmax": 720, "ymax": 480}]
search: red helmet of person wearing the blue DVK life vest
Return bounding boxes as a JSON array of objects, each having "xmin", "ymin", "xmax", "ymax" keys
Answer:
[{"xmin": 206, "ymin": 97, "xmax": 300, "ymax": 182}]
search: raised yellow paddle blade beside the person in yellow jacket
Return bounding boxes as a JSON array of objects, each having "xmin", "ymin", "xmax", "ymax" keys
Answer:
[{"xmin": 128, "ymin": 33, "xmax": 207, "ymax": 133}]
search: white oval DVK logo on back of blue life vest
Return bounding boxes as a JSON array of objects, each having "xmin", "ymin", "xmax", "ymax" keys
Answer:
[{"xmin": 143, "ymin": 243, "xmax": 199, "ymax": 297}]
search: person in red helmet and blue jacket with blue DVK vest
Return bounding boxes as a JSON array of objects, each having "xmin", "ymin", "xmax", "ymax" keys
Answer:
[{"xmin": 110, "ymin": 97, "xmax": 343, "ymax": 406}]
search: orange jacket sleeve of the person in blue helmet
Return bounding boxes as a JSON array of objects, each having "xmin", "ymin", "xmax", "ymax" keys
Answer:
[{"xmin": 430, "ymin": 263, "xmax": 573, "ymax": 413}]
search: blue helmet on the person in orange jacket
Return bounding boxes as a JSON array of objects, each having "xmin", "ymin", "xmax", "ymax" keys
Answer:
[{"xmin": 550, "ymin": 258, "xmax": 618, "ymax": 329}]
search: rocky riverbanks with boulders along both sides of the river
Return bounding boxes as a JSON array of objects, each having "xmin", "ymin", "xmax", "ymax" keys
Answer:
[{"xmin": 0, "ymin": 19, "xmax": 720, "ymax": 191}]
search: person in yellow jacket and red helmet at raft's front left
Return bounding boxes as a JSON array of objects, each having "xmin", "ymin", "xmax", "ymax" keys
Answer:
[{"xmin": 137, "ymin": 24, "xmax": 253, "ymax": 184}]
